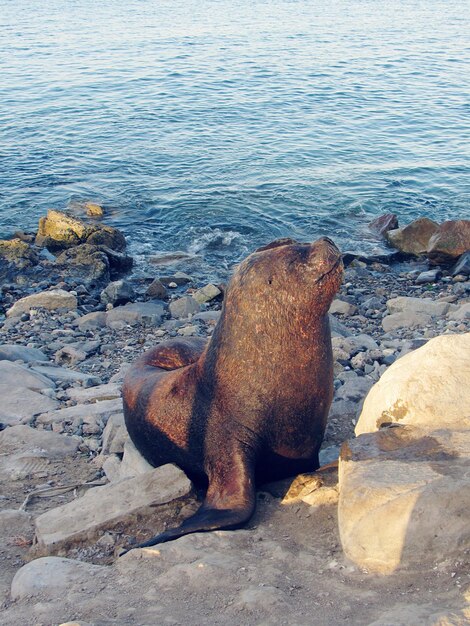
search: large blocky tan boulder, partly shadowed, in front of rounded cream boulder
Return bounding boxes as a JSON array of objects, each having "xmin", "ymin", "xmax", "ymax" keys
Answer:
[{"xmin": 338, "ymin": 426, "xmax": 470, "ymax": 574}]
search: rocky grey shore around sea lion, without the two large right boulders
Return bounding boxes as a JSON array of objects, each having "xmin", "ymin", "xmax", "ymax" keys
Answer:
[{"xmin": 0, "ymin": 210, "xmax": 470, "ymax": 626}]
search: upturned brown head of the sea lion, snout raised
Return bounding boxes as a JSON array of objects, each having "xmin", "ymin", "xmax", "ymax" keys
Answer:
[{"xmin": 226, "ymin": 237, "xmax": 343, "ymax": 315}]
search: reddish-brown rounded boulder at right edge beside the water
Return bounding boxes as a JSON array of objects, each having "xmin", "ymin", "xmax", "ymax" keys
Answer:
[{"xmin": 427, "ymin": 220, "xmax": 470, "ymax": 265}]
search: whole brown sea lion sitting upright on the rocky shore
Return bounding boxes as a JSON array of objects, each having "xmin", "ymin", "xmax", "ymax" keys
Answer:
[{"xmin": 123, "ymin": 237, "xmax": 343, "ymax": 547}]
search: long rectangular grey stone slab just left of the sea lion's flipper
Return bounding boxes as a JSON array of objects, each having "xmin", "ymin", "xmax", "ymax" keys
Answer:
[{"xmin": 36, "ymin": 465, "xmax": 191, "ymax": 554}]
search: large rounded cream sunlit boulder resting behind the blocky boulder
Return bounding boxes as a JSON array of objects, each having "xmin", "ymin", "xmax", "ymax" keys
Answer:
[{"xmin": 355, "ymin": 333, "xmax": 470, "ymax": 435}]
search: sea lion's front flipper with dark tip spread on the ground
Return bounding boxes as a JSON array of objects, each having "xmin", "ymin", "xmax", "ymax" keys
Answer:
[{"xmin": 121, "ymin": 444, "xmax": 255, "ymax": 556}]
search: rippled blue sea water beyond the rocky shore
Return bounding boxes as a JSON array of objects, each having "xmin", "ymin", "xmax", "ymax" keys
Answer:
[{"xmin": 0, "ymin": 0, "xmax": 470, "ymax": 273}]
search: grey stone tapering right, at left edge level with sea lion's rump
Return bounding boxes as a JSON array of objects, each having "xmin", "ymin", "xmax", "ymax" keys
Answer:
[{"xmin": 0, "ymin": 383, "xmax": 60, "ymax": 425}]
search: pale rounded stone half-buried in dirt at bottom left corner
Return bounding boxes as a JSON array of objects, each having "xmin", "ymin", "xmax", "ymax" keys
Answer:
[{"xmin": 11, "ymin": 556, "xmax": 109, "ymax": 601}]
